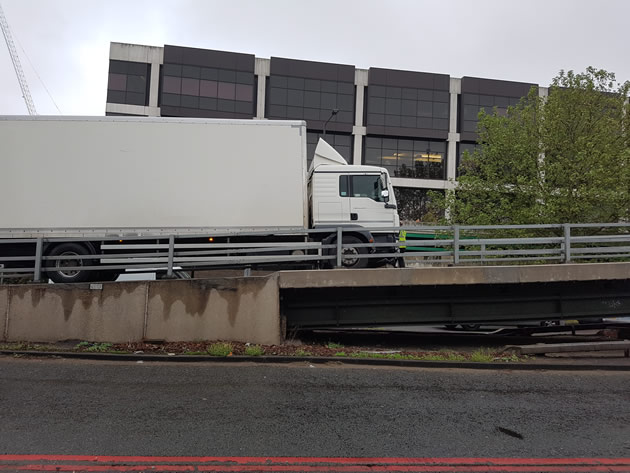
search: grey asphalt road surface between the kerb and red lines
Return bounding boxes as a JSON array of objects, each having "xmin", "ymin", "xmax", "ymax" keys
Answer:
[{"xmin": 0, "ymin": 357, "xmax": 630, "ymax": 458}]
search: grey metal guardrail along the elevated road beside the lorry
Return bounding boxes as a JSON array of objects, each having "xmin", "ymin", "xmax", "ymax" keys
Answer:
[{"xmin": 0, "ymin": 223, "xmax": 630, "ymax": 283}]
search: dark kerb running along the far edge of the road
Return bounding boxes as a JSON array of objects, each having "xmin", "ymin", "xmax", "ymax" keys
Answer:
[{"xmin": 0, "ymin": 350, "xmax": 630, "ymax": 371}]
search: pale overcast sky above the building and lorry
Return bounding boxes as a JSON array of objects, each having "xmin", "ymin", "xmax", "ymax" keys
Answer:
[{"xmin": 0, "ymin": 0, "xmax": 630, "ymax": 115}]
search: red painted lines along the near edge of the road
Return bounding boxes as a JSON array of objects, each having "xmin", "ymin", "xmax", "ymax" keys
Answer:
[{"xmin": 0, "ymin": 455, "xmax": 630, "ymax": 473}]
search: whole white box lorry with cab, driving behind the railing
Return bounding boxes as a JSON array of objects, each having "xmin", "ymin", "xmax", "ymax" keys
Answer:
[{"xmin": 0, "ymin": 116, "xmax": 399, "ymax": 282}]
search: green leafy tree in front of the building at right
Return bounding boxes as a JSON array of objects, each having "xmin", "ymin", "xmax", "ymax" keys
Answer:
[{"xmin": 432, "ymin": 67, "xmax": 630, "ymax": 225}]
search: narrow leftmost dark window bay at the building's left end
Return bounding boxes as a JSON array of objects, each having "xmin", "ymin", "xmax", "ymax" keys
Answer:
[{"xmin": 107, "ymin": 60, "xmax": 151, "ymax": 106}]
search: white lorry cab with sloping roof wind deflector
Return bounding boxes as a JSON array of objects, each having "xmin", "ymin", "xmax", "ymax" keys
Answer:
[{"xmin": 308, "ymin": 139, "xmax": 399, "ymax": 232}]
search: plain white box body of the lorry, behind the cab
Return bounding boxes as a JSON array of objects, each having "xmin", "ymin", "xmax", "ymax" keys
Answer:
[{"xmin": 0, "ymin": 116, "xmax": 308, "ymax": 231}]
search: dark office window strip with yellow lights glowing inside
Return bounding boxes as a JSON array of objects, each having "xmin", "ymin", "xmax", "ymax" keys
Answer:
[{"xmin": 363, "ymin": 137, "xmax": 446, "ymax": 179}]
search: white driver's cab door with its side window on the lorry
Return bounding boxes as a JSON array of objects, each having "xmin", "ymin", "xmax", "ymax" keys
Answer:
[{"xmin": 348, "ymin": 174, "xmax": 396, "ymax": 227}]
